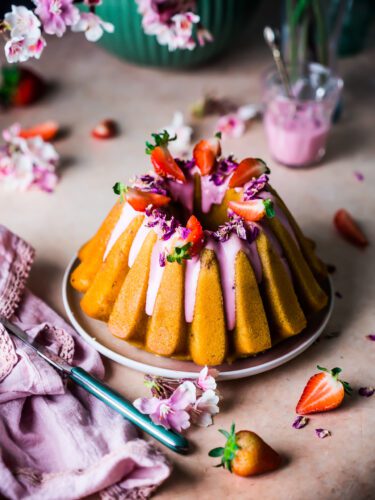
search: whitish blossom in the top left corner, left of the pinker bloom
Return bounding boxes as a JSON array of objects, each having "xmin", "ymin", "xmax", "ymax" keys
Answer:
[{"xmin": 4, "ymin": 5, "xmax": 41, "ymax": 44}]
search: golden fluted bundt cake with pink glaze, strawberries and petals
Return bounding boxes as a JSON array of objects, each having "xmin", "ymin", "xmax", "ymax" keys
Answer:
[{"xmin": 71, "ymin": 132, "xmax": 328, "ymax": 366}]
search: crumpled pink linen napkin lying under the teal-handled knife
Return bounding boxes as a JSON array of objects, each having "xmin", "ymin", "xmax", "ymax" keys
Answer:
[{"xmin": 0, "ymin": 226, "xmax": 170, "ymax": 500}]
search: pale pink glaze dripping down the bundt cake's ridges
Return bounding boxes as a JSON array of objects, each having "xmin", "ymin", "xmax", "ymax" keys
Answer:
[{"xmin": 104, "ymin": 169, "xmax": 298, "ymax": 330}]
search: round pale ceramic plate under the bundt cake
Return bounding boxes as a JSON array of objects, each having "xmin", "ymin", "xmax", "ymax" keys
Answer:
[{"xmin": 62, "ymin": 257, "xmax": 333, "ymax": 380}]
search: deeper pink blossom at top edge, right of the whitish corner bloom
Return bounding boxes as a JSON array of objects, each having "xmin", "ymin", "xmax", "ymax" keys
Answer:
[{"xmin": 33, "ymin": 0, "xmax": 79, "ymax": 37}]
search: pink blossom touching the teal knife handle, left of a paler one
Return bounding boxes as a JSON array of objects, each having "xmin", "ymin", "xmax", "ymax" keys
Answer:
[{"xmin": 134, "ymin": 381, "xmax": 196, "ymax": 432}]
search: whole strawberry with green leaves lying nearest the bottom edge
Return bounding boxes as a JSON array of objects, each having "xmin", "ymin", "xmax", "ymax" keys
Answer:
[{"xmin": 209, "ymin": 424, "xmax": 281, "ymax": 477}]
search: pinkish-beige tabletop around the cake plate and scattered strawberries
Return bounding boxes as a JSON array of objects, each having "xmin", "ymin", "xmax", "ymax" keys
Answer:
[{"xmin": 0, "ymin": 28, "xmax": 375, "ymax": 500}]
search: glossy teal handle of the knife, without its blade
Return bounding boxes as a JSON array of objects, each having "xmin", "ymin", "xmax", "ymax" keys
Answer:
[{"xmin": 69, "ymin": 367, "xmax": 189, "ymax": 454}]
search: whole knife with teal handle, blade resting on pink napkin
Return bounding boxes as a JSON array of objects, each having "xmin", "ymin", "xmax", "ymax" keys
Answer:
[{"xmin": 0, "ymin": 316, "xmax": 189, "ymax": 454}]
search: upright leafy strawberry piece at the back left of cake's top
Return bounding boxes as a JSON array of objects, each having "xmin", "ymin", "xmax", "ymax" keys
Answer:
[{"xmin": 146, "ymin": 130, "xmax": 186, "ymax": 182}]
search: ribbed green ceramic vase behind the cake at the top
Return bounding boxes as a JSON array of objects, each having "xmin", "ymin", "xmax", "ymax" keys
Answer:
[{"xmin": 97, "ymin": 0, "xmax": 259, "ymax": 68}]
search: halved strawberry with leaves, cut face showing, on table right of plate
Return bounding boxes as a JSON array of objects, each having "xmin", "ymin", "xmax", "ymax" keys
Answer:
[{"xmin": 296, "ymin": 366, "xmax": 352, "ymax": 415}]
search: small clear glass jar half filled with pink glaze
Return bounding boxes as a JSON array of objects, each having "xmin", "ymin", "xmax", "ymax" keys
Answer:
[{"xmin": 263, "ymin": 63, "xmax": 343, "ymax": 167}]
